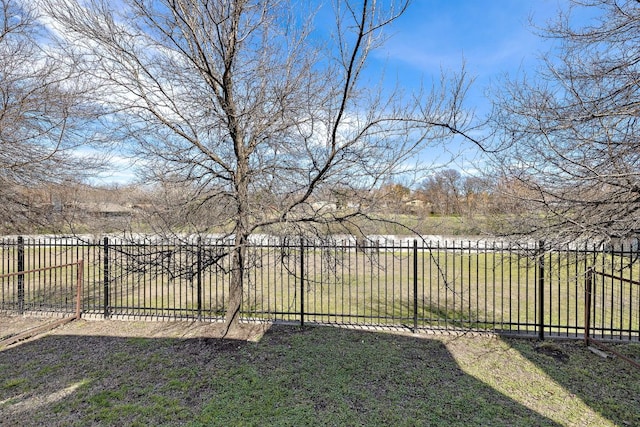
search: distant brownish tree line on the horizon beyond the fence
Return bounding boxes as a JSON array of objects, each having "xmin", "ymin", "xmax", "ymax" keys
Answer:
[{"xmin": 4, "ymin": 169, "xmax": 530, "ymax": 234}]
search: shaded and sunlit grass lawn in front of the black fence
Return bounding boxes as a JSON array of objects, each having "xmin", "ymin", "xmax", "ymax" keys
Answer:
[{"xmin": 0, "ymin": 318, "xmax": 640, "ymax": 426}]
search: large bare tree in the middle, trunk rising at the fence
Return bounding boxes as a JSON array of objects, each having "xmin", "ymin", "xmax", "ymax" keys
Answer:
[{"xmin": 45, "ymin": 0, "xmax": 476, "ymax": 327}]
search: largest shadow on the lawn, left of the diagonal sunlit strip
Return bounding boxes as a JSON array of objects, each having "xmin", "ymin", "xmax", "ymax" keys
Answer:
[{"xmin": 0, "ymin": 326, "xmax": 557, "ymax": 426}]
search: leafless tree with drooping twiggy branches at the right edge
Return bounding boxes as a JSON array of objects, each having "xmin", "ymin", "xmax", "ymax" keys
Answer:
[{"xmin": 493, "ymin": 0, "xmax": 640, "ymax": 246}]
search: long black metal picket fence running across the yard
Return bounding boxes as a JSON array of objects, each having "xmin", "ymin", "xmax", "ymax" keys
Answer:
[{"xmin": 0, "ymin": 237, "xmax": 640, "ymax": 340}]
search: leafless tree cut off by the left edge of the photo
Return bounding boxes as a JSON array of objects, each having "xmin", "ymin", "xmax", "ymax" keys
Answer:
[{"xmin": 0, "ymin": 0, "xmax": 105, "ymax": 232}]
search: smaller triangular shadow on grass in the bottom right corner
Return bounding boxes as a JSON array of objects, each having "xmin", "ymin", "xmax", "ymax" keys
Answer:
[{"xmin": 504, "ymin": 339, "xmax": 640, "ymax": 426}]
